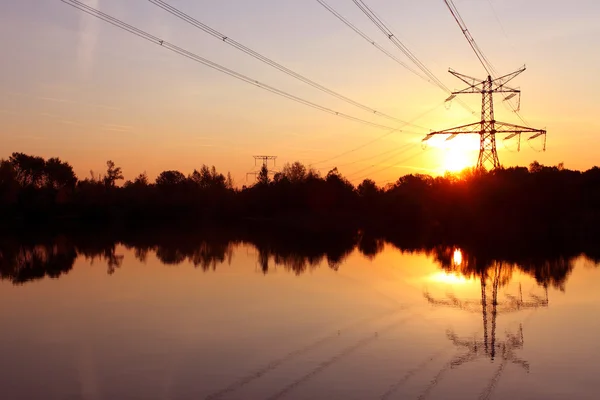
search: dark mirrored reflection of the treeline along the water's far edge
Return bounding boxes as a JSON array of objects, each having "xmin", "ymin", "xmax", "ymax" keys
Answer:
[{"xmin": 0, "ymin": 228, "xmax": 600, "ymax": 290}]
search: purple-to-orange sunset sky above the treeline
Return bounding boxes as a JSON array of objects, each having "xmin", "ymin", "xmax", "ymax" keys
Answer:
[{"xmin": 0, "ymin": 0, "xmax": 600, "ymax": 185}]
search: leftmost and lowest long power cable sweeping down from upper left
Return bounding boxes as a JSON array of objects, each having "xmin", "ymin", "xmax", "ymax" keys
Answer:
[{"xmin": 60, "ymin": 0, "xmax": 420, "ymax": 133}]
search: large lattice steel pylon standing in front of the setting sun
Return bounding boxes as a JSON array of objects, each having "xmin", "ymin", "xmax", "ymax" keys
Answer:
[{"xmin": 422, "ymin": 67, "xmax": 546, "ymax": 169}]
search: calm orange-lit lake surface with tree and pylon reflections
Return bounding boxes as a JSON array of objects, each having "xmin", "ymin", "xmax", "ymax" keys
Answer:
[{"xmin": 0, "ymin": 236, "xmax": 600, "ymax": 400}]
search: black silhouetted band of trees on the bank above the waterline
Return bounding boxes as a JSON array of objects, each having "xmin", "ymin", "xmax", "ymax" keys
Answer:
[{"xmin": 0, "ymin": 153, "xmax": 600, "ymax": 245}]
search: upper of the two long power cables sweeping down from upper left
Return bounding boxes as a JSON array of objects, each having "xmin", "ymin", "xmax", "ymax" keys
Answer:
[{"xmin": 148, "ymin": 0, "xmax": 422, "ymax": 128}]
